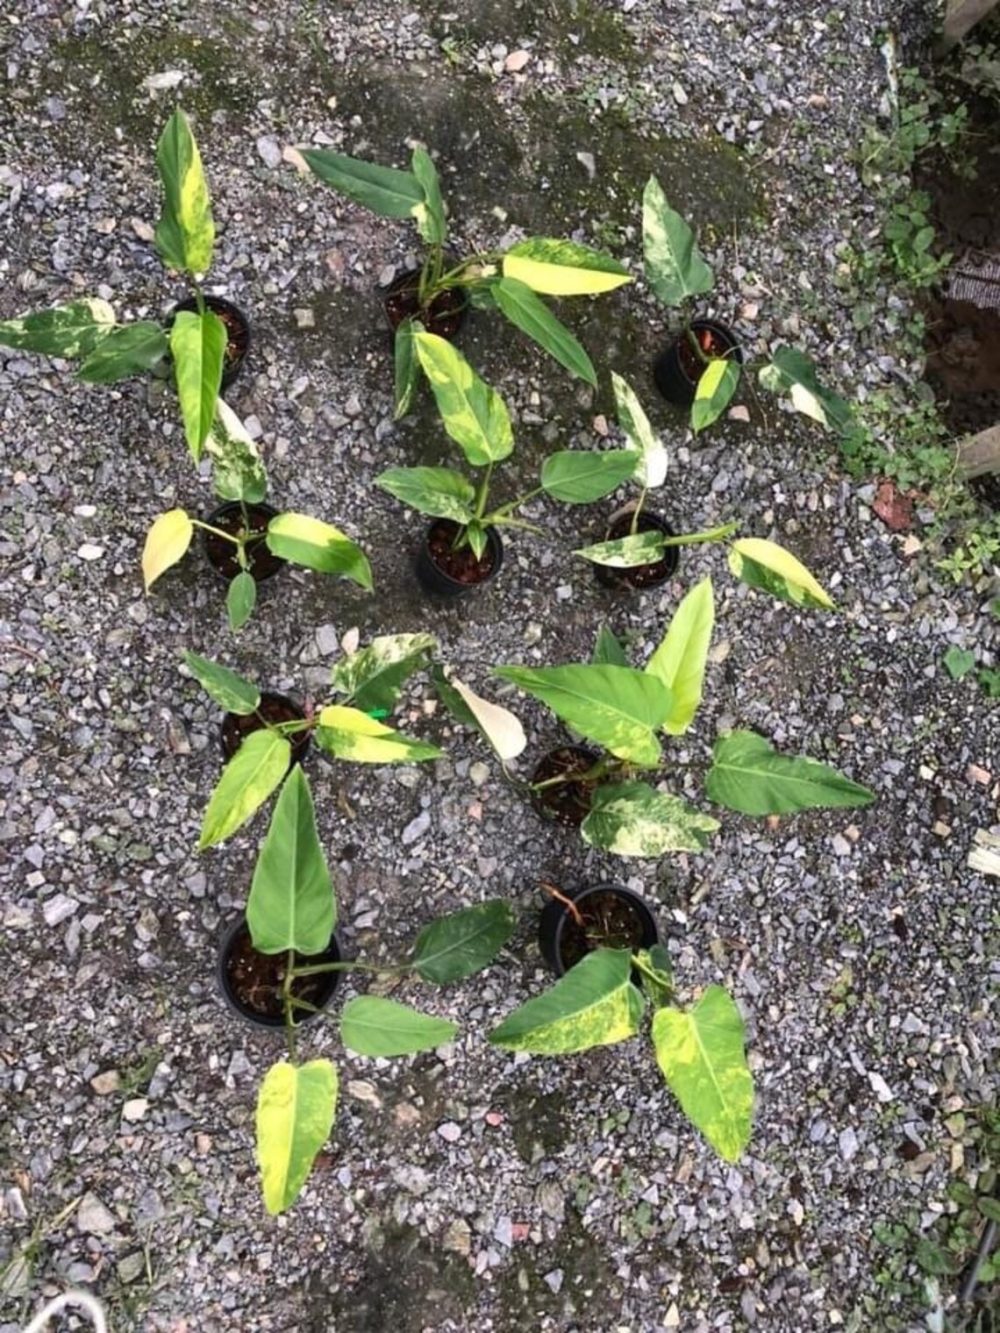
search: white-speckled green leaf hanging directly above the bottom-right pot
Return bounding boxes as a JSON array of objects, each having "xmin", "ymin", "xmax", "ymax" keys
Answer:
[{"xmin": 580, "ymin": 782, "xmax": 719, "ymax": 856}]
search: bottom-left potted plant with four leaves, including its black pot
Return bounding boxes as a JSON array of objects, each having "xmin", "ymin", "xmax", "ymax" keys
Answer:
[{"xmin": 226, "ymin": 768, "xmax": 515, "ymax": 1214}]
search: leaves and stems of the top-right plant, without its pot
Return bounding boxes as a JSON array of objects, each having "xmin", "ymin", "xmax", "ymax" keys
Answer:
[{"xmin": 643, "ymin": 176, "xmax": 852, "ymax": 435}]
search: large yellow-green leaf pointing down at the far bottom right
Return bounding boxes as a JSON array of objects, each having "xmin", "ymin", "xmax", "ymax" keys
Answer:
[{"xmin": 652, "ymin": 986, "xmax": 753, "ymax": 1162}]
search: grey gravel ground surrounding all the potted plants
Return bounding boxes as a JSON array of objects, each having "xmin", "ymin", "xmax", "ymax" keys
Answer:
[{"xmin": 0, "ymin": 0, "xmax": 1000, "ymax": 1333}]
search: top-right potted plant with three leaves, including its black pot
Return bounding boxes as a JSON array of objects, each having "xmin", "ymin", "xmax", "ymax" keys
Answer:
[{"xmin": 643, "ymin": 176, "xmax": 852, "ymax": 433}]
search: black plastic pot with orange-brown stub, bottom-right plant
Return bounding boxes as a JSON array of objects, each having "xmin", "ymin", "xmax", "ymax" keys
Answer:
[{"xmin": 539, "ymin": 884, "xmax": 660, "ymax": 977}]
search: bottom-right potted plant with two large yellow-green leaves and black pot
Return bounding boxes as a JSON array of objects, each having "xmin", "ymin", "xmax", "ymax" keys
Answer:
[{"xmin": 489, "ymin": 885, "xmax": 753, "ymax": 1162}]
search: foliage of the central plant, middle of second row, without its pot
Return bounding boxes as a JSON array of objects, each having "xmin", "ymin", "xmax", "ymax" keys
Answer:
[{"xmin": 375, "ymin": 338, "xmax": 636, "ymax": 559}]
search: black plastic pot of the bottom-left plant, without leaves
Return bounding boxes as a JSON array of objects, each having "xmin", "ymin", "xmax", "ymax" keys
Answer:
[{"xmin": 216, "ymin": 916, "xmax": 341, "ymax": 1028}]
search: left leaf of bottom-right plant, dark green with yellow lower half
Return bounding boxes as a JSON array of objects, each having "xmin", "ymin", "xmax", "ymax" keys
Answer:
[{"xmin": 489, "ymin": 949, "xmax": 645, "ymax": 1056}]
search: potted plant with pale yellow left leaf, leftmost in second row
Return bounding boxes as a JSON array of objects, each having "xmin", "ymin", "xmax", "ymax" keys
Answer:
[{"xmin": 143, "ymin": 399, "xmax": 372, "ymax": 631}]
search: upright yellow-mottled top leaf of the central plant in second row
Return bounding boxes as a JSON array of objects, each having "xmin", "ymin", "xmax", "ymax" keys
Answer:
[{"xmin": 413, "ymin": 333, "xmax": 513, "ymax": 468}]
